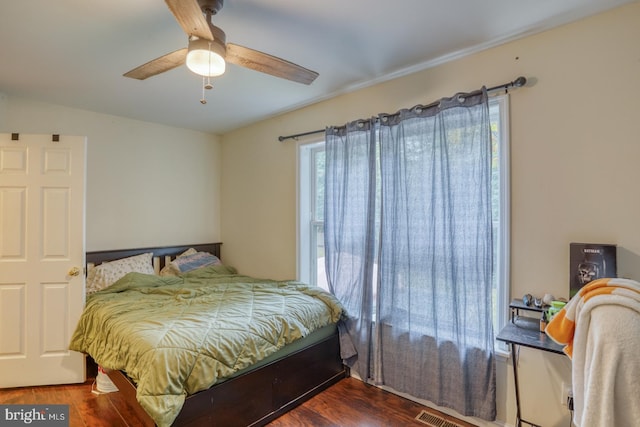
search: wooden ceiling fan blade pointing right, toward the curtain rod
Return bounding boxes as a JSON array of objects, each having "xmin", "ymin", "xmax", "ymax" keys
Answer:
[{"xmin": 225, "ymin": 43, "xmax": 318, "ymax": 85}]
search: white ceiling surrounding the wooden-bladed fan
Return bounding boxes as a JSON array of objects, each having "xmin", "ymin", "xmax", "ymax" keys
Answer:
[{"xmin": 0, "ymin": 0, "xmax": 634, "ymax": 134}]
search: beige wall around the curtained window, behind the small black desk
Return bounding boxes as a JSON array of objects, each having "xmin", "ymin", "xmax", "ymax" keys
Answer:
[{"xmin": 222, "ymin": 3, "xmax": 640, "ymax": 426}]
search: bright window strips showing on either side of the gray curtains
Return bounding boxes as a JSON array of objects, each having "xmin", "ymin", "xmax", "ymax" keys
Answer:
[{"xmin": 298, "ymin": 95, "xmax": 510, "ymax": 340}]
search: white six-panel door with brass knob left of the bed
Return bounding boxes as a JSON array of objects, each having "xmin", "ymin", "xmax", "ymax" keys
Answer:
[{"xmin": 0, "ymin": 134, "xmax": 86, "ymax": 388}]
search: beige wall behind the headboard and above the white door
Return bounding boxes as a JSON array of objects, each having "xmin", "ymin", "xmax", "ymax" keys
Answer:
[{"xmin": 0, "ymin": 93, "xmax": 221, "ymax": 250}]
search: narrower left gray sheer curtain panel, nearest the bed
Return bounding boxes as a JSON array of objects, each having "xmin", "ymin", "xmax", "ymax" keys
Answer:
[{"xmin": 324, "ymin": 120, "xmax": 377, "ymax": 378}]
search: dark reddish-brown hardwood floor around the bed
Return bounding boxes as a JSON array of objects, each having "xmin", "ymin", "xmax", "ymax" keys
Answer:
[{"xmin": 0, "ymin": 378, "xmax": 473, "ymax": 427}]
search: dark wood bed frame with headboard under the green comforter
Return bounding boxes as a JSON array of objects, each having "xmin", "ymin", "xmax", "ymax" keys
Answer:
[{"xmin": 86, "ymin": 243, "xmax": 348, "ymax": 427}]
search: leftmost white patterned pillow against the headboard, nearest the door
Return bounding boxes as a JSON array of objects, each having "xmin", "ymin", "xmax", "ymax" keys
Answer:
[{"xmin": 86, "ymin": 252, "xmax": 155, "ymax": 295}]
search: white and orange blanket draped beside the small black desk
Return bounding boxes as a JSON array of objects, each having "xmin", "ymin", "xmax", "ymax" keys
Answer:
[{"xmin": 546, "ymin": 279, "xmax": 640, "ymax": 427}]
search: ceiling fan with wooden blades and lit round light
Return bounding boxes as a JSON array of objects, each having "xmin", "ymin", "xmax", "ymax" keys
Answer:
[{"xmin": 124, "ymin": 0, "xmax": 318, "ymax": 85}]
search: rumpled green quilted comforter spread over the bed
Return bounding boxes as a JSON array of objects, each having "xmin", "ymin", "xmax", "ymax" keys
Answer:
[{"xmin": 70, "ymin": 266, "xmax": 343, "ymax": 426}]
